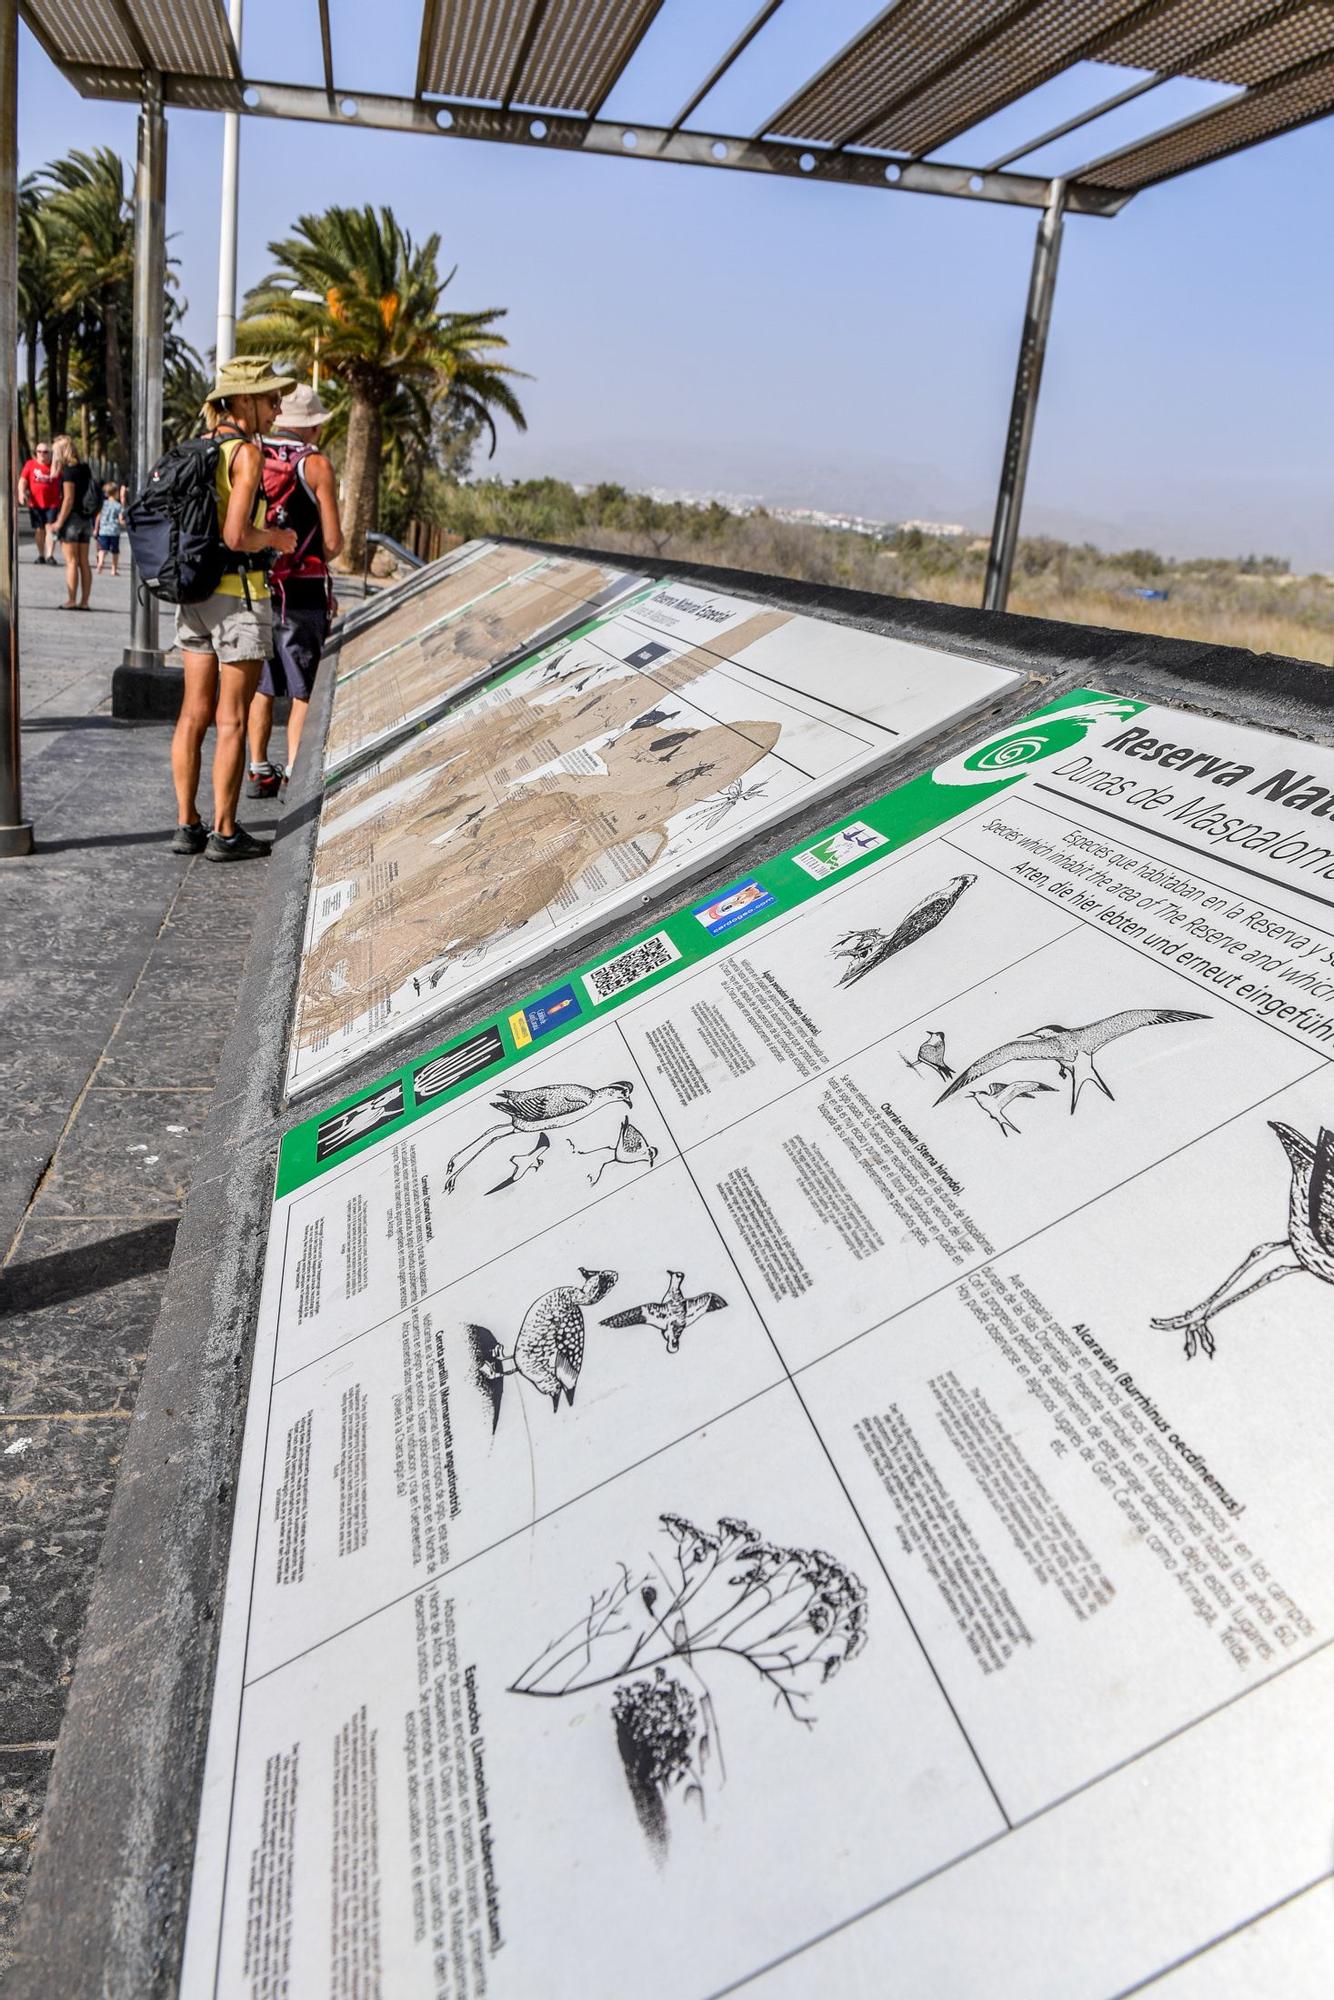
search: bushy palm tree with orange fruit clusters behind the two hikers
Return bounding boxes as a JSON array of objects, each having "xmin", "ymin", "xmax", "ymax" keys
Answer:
[{"xmin": 236, "ymin": 206, "xmax": 528, "ymax": 570}]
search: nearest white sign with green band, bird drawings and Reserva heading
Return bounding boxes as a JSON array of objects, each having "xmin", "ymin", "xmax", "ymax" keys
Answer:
[{"xmin": 184, "ymin": 692, "xmax": 1334, "ymax": 2000}]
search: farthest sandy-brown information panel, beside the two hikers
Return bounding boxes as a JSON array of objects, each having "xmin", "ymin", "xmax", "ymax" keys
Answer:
[{"xmin": 324, "ymin": 542, "xmax": 642, "ymax": 778}]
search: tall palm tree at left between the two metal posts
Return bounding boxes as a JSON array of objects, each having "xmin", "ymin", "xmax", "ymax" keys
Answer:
[{"xmin": 36, "ymin": 146, "xmax": 134, "ymax": 464}]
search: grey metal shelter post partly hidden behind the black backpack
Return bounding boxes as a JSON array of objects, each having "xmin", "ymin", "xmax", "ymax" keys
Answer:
[{"xmin": 124, "ymin": 72, "xmax": 166, "ymax": 666}]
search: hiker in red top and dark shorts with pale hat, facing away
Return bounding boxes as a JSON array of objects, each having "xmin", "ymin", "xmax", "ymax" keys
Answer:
[{"xmin": 246, "ymin": 382, "xmax": 342, "ymax": 798}]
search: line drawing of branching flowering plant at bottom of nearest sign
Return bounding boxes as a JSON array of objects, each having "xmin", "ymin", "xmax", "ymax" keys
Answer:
[{"xmin": 510, "ymin": 1514, "xmax": 866, "ymax": 1852}]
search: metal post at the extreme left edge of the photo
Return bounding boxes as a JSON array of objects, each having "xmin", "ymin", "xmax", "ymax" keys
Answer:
[{"xmin": 0, "ymin": 0, "xmax": 32, "ymax": 856}]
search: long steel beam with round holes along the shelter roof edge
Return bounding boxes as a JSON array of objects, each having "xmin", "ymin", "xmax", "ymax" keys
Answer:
[{"xmin": 64, "ymin": 64, "xmax": 1132, "ymax": 216}]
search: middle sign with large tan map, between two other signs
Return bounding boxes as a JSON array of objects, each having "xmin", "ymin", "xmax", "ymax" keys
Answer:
[{"xmin": 288, "ymin": 578, "xmax": 1016, "ymax": 1092}]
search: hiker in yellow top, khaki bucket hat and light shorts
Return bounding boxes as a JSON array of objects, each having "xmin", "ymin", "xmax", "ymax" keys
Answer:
[{"xmin": 172, "ymin": 354, "xmax": 296, "ymax": 862}]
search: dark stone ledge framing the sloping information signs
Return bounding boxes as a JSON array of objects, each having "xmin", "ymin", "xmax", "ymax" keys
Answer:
[{"xmin": 15, "ymin": 550, "xmax": 1334, "ymax": 2000}]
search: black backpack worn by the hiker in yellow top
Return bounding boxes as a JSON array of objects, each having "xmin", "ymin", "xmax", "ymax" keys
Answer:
[{"xmin": 126, "ymin": 436, "xmax": 268, "ymax": 604}]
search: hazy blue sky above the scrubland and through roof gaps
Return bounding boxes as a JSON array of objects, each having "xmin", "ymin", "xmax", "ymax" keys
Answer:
[{"xmin": 20, "ymin": 0, "xmax": 1334, "ymax": 570}]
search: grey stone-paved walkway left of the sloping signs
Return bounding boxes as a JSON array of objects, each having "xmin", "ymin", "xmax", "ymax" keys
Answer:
[{"xmin": 0, "ymin": 544, "xmax": 282, "ymax": 1968}]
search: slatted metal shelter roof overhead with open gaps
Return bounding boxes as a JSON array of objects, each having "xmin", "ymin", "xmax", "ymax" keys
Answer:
[{"xmin": 20, "ymin": 0, "xmax": 1334, "ymax": 200}]
